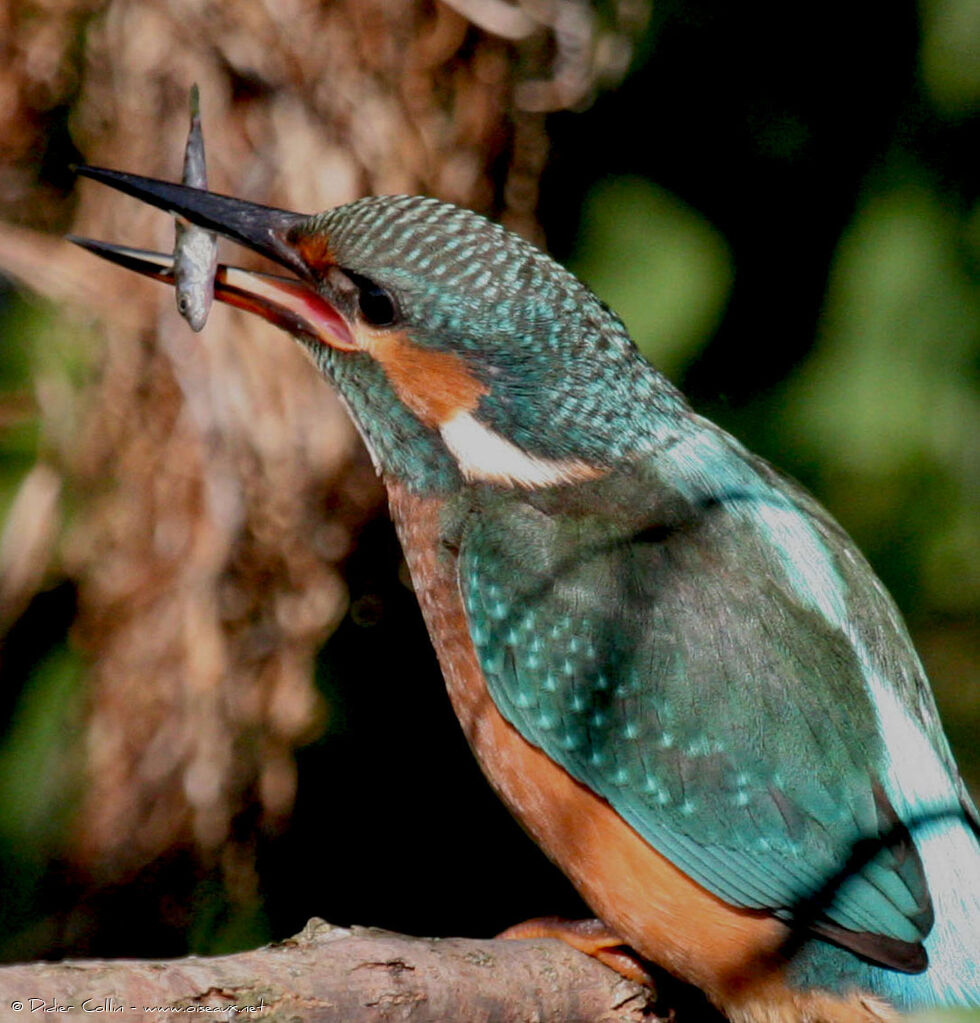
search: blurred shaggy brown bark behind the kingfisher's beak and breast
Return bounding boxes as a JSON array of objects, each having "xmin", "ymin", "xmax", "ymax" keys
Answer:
[{"xmin": 0, "ymin": 0, "xmax": 642, "ymax": 888}]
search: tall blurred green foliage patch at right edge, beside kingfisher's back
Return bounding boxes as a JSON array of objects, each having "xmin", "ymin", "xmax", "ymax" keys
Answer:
[{"xmin": 785, "ymin": 183, "xmax": 980, "ymax": 615}]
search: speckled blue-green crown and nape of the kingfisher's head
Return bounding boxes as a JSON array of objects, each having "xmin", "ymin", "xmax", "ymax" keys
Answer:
[{"xmin": 310, "ymin": 195, "xmax": 686, "ymax": 474}]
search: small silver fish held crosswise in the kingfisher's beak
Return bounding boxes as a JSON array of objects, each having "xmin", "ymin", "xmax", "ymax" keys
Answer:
[{"xmin": 174, "ymin": 85, "xmax": 218, "ymax": 330}]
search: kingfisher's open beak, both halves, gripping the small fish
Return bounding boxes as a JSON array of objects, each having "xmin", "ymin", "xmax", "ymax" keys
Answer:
[{"xmin": 69, "ymin": 167, "xmax": 357, "ymax": 351}]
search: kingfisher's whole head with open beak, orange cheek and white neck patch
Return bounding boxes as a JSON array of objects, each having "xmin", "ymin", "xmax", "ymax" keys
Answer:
[{"xmin": 75, "ymin": 168, "xmax": 684, "ymax": 491}]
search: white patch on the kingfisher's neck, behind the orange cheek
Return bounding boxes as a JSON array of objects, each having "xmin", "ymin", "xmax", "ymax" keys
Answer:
[{"xmin": 439, "ymin": 411, "xmax": 603, "ymax": 488}]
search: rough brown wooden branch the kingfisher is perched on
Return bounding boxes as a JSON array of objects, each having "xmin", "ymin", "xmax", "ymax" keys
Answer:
[{"xmin": 0, "ymin": 919, "xmax": 655, "ymax": 1023}]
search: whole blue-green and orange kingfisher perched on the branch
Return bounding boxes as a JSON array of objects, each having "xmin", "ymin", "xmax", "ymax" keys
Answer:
[{"xmin": 73, "ymin": 167, "xmax": 980, "ymax": 1023}]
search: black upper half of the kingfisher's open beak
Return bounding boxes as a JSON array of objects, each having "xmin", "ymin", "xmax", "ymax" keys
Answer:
[{"xmin": 75, "ymin": 166, "xmax": 310, "ymax": 278}]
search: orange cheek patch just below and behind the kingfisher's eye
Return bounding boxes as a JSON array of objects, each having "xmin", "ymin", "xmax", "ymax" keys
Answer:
[{"xmin": 357, "ymin": 328, "xmax": 488, "ymax": 428}]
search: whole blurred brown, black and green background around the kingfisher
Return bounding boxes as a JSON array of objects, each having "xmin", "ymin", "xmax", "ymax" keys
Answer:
[{"xmin": 0, "ymin": 0, "xmax": 980, "ymax": 960}]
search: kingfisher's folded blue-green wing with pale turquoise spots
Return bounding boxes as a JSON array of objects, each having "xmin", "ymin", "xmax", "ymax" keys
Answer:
[{"xmin": 459, "ymin": 443, "xmax": 931, "ymax": 966}]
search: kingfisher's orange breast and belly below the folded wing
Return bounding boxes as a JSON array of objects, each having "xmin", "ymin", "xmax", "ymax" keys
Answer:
[{"xmin": 389, "ymin": 484, "xmax": 892, "ymax": 1023}]
